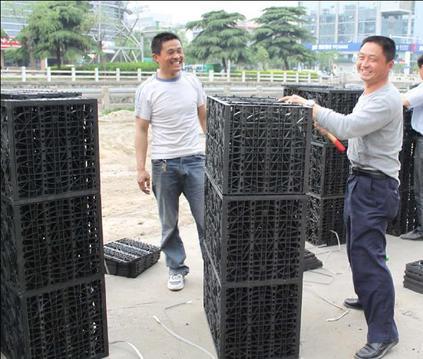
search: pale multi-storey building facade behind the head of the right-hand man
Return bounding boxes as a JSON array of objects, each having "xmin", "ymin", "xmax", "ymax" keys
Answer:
[{"xmin": 298, "ymin": 1, "xmax": 423, "ymax": 72}]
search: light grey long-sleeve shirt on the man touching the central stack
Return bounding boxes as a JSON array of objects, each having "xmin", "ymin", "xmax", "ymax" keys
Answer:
[{"xmin": 317, "ymin": 83, "xmax": 403, "ymax": 181}]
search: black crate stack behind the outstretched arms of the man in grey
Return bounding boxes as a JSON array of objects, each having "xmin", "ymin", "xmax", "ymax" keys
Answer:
[{"xmin": 284, "ymin": 86, "xmax": 363, "ymax": 246}]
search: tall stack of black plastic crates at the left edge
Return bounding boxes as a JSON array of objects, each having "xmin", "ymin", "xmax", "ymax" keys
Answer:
[{"xmin": 1, "ymin": 91, "xmax": 108, "ymax": 359}]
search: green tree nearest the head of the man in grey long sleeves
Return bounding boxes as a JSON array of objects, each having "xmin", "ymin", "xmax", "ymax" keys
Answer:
[{"xmin": 254, "ymin": 7, "xmax": 314, "ymax": 69}]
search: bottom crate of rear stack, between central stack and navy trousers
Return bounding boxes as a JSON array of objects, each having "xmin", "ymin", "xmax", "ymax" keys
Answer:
[{"xmin": 306, "ymin": 194, "xmax": 346, "ymax": 246}]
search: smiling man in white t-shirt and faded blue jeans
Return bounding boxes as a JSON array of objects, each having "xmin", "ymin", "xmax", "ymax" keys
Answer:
[{"xmin": 135, "ymin": 32, "xmax": 206, "ymax": 290}]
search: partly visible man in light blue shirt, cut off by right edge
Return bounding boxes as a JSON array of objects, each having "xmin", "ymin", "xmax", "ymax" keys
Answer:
[{"xmin": 401, "ymin": 55, "xmax": 423, "ymax": 241}]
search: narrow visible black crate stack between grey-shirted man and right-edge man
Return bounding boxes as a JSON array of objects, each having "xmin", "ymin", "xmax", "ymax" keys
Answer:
[{"xmin": 386, "ymin": 109, "xmax": 417, "ymax": 236}]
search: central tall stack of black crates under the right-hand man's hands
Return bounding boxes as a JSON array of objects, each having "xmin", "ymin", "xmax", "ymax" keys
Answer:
[{"xmin": 204, "ymin": 97, "xmax": 311, "ymax": 359}]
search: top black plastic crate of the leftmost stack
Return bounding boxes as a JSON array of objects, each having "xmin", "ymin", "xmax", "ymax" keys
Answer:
[{"xmin": 1, "ymin": 98, "xmax": 100, "ymax": 200}]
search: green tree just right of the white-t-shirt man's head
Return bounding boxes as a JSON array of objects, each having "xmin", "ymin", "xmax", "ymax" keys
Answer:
[{"xmin": 186, "ymin": 10, "xmax": 249, "ymax": 72}]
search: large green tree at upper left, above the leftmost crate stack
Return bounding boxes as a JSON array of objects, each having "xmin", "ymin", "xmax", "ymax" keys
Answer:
[{"xmin": 18, "ymin": 1, "xmax": 94, "ymax": 68}]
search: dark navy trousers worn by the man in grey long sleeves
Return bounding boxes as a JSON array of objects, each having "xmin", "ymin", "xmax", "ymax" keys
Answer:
[{"xmin": 344, "ymin": 175, "xmax": 399, "ymax": 343}]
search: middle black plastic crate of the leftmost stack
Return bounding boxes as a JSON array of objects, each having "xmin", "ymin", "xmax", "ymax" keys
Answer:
[{"xmin": 1, "ymin": 194, "xmax": 104, "ymax": 290}]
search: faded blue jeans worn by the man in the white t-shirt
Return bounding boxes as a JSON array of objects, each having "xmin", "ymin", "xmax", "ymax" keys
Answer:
[{"xmin": 151, "ymin": 155, "xmax": 205, "ymax": 275}]
